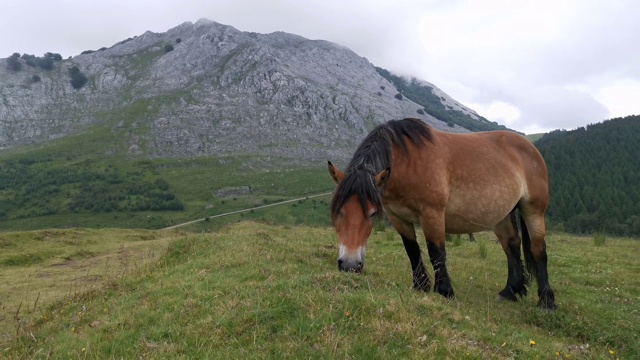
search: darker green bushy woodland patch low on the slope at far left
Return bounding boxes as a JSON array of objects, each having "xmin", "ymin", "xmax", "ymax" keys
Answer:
[{"xmin": 0, "ymin": 158, "xmax": 184, "ymax": 219}]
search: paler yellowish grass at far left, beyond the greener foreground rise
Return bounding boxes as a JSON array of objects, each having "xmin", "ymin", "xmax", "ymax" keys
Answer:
[{"xmin": 0, "ymin": 229, "xmax": 180, "ymax": 342}]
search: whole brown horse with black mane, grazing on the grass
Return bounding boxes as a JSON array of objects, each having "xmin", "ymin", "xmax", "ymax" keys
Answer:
[{"xmin": 329, "ymin": 119, "xmax": 556, "ymax": 310}]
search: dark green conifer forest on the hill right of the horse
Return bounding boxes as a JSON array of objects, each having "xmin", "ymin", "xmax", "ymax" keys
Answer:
[{"xmin": 535, "ymin": 116, "xmax": 640, "ymax": 237}]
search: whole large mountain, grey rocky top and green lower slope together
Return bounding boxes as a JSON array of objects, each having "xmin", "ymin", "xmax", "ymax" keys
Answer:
[{"xmin": 0, "ymin": 19, "xmax": 510, "ymax": 230}]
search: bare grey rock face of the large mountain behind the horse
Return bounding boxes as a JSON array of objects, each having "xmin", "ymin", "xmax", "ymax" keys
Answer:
[{"xmin": 0, "ymin": 19, "xmax": 475, "ymax": 160}]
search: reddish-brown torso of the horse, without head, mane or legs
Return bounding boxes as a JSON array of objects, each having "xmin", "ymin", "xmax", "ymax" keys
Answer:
[{"xmin": 385, "ymin": 130, "xmax": 547, "ymax": 233}]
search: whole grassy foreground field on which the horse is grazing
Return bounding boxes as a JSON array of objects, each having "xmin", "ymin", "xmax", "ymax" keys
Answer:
[{"xmin": 0, "ymin": 221, "xmax": 640, "ymax": 359}]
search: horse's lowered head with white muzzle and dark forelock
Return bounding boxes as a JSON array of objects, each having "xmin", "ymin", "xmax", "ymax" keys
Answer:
[{"xmin": 329, "ymin": 162, "xmax": 390, "ymax": 273}]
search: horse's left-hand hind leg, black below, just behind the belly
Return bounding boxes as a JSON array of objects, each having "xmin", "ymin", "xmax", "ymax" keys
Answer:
[{"xmin": 493, "ymin": 210, "xmax": 527, "ymax": 301}]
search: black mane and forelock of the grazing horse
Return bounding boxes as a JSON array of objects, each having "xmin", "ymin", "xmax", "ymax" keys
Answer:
[{"xmin": 331, "ymin": 118, "xmax": 433, "ymax": 219}]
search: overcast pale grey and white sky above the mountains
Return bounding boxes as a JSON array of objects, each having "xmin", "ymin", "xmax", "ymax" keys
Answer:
[{"xmin": 0, "ymin": 0, "xmax": 640, "ymax": 133}]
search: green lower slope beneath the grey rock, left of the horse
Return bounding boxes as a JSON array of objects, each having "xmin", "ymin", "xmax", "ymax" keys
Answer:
[{"xmin": 0, "ymin": 128, "xmax": 333, "ymax": 231}]
